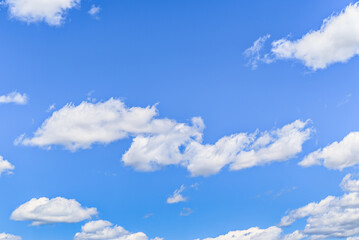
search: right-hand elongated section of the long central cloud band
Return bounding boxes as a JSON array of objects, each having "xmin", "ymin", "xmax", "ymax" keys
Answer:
[{"xmin": 185, "ymin": 120, "xmax": 311, "ymax": 176}]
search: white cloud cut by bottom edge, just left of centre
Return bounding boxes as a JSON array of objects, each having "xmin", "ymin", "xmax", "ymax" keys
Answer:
[{"xmin": 74, "ymin": 220, "xmax": 161, "ymax": 240}]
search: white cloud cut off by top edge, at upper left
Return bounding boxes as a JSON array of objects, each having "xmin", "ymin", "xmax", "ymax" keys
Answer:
[{"xmin": 4, "ymin": 0, "xmax": 80, "ymax": 25}]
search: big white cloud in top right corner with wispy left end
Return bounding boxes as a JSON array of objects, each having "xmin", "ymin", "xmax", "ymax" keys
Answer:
[{"xmin": 245, "ymin": 2, "xmax": 359, "ymax": 70}]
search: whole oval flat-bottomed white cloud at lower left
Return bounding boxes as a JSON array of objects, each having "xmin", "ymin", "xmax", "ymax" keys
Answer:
[{"xmin": 10, "ymin": 197, "xmax": 97, "ymax": 225}]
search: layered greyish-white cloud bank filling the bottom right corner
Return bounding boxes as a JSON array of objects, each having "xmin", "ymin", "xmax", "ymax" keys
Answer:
[{"xmin": 280, "ymin": 176, "xmax": 359, "ymax": 239}]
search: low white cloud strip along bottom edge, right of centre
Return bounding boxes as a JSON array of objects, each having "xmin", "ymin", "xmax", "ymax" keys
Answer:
[{"xmin": 197, "ymin": 227, "xmax": 305, "ymax": 240}]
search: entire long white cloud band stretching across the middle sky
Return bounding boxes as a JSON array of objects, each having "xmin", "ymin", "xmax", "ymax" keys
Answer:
[{"xmin": 15, "ymin": 98, "xmax": 312, "ymax": 176}]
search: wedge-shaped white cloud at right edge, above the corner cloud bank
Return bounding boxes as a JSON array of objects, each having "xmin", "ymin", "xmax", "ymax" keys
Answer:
[{"xmin": 299, "ymin": 132, "xmax": 359, "ymax": 170}]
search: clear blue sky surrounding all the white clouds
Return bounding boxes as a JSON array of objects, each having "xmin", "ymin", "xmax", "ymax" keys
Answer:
[{"xmin": 0, "ymin": 0, "xmax": 359, "ymax": 240}]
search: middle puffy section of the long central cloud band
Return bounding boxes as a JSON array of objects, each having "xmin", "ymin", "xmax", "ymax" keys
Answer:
[{"xmin": 122, "ymin": 118, "xmax": 204, "ymax": 171}]
